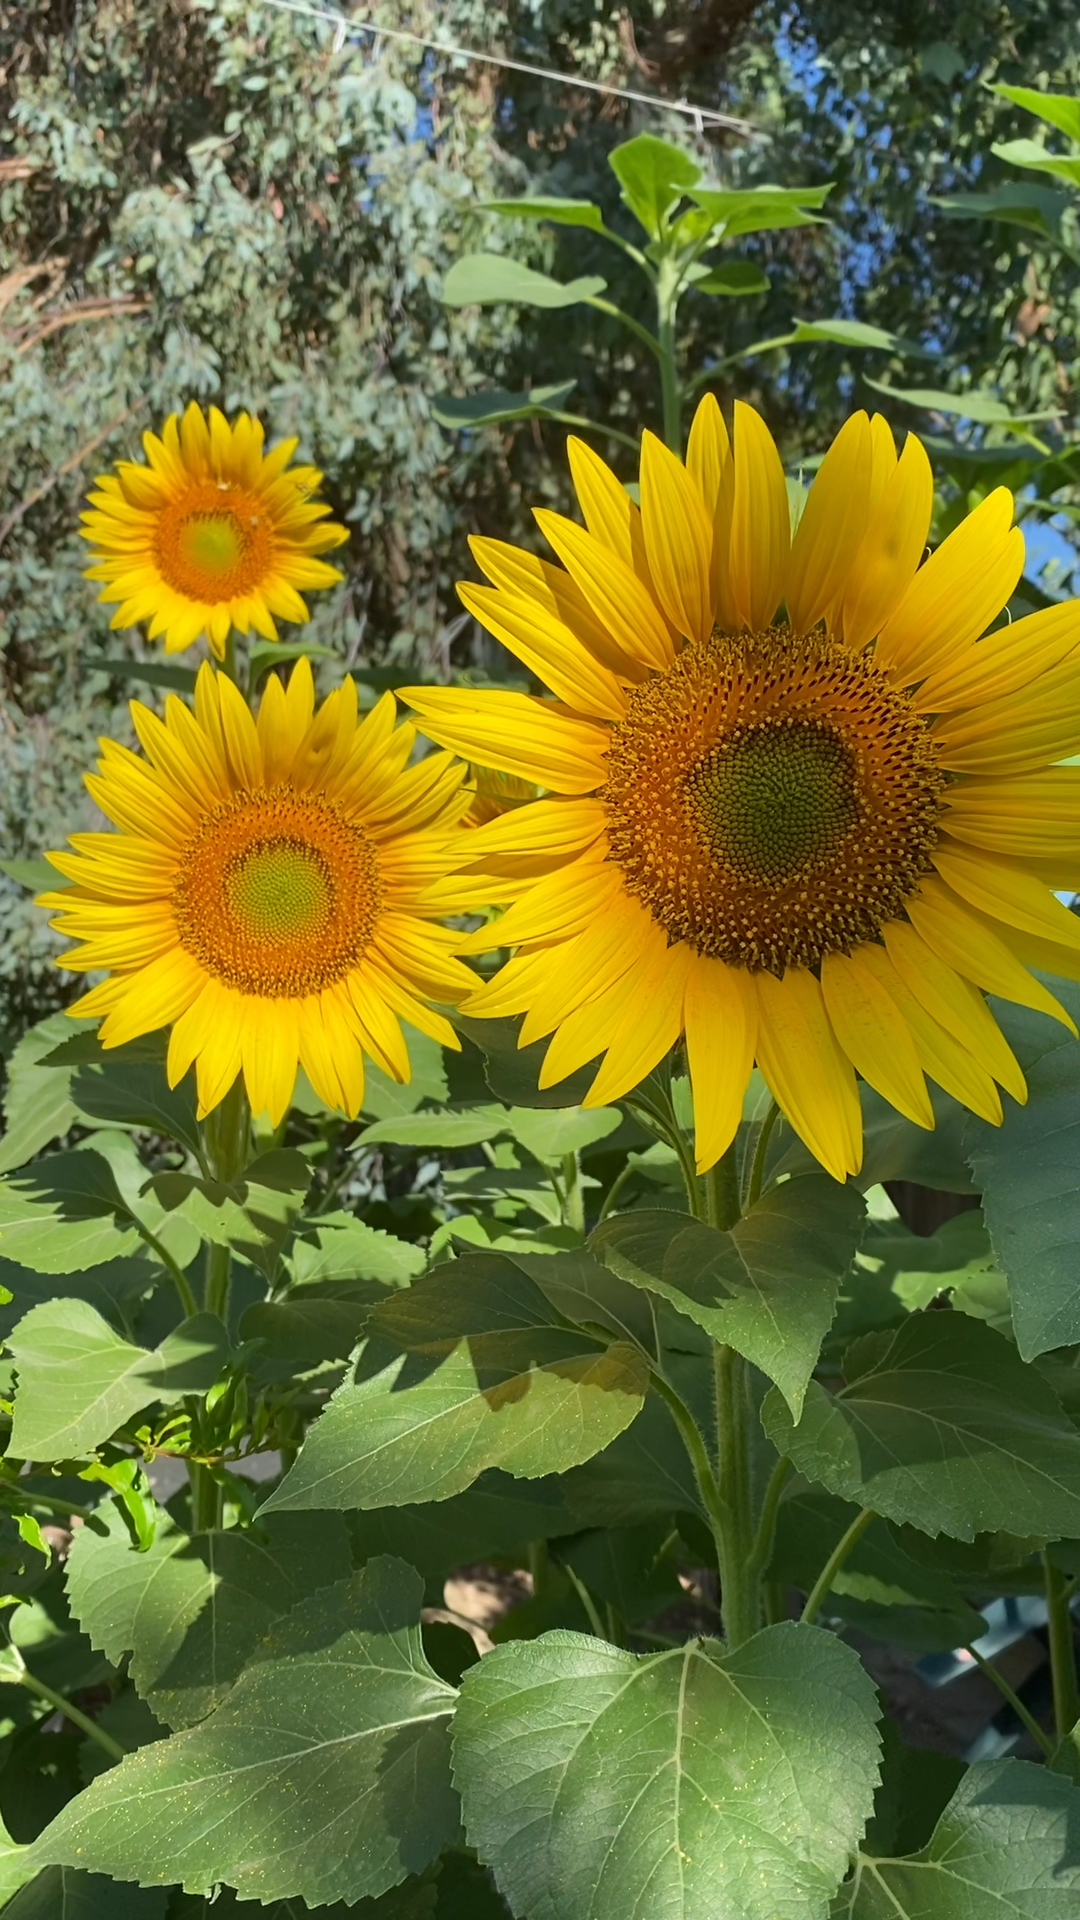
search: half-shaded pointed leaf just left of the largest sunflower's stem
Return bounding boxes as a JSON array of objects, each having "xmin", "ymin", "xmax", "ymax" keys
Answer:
[{"xmin": 261, "ymin": 1254, "xmax": 648, "ymax": 1511}]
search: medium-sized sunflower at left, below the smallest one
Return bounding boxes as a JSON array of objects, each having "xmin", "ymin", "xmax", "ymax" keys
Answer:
[{"xmin": 38, "ymin": 659, "xmax": 475, "ymax": 1125}]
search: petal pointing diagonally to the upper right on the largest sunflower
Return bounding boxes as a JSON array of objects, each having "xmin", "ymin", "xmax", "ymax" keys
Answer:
[{"xmin": 874, "ymin": 486, "xmax": 1024, "ymax": 680}]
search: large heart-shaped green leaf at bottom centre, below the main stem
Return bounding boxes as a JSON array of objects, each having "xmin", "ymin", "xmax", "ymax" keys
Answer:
[{"xmin": 454, "ymin": 1624, "xmax": 878, "ymax": 1920}]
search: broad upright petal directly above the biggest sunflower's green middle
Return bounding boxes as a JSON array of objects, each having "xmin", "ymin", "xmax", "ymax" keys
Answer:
[{"xmin": 728, "ymin": 399, "xmax": 780, "ymax": 634}]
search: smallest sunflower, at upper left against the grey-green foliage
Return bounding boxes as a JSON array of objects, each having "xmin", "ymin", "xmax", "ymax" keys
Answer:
[{"xmin": 83, "ymin": 399, "xmax": 348, "ymax": 659}]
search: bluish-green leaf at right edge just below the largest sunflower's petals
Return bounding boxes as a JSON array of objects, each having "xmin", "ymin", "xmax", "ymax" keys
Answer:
[{"xmin": 965, "ymin": 979, "xmax": 1080, "ymax": 1359}]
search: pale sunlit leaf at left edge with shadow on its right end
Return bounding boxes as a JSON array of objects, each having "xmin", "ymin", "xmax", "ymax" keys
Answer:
[{"xmin": 8, "ymin": 1300, "xmax": 229, "ymax": 1459}]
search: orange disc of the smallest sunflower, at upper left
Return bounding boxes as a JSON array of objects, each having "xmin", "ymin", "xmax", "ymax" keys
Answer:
[{"xmin": 154, "ymin": 480, "xmax": 273, "ymax": 605}]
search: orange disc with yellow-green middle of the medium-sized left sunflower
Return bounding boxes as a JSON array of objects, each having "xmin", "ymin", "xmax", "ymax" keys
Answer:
[{"xmin": 173, "ymin": 783, "xmax": 382, "ymax": 998}]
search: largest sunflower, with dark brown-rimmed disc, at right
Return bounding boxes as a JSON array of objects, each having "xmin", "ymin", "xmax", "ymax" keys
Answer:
[{"xmin": 404, "ymin": 397, "xmax": 1080, "ymax": 1179}]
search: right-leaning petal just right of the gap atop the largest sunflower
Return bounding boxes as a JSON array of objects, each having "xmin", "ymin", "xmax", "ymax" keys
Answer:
[{"xmin": 784, "ymin": 413, "xmax": 871, "ymax": 634}]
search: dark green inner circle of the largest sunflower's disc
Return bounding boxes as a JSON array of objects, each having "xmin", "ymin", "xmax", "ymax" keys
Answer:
[{"xmin": 686, "ymin": 718, "xmax": 859, "ymax": 881}]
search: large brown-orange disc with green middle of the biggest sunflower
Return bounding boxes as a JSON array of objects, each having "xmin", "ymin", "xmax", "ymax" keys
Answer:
[{"xmin": 601, "ymin": 628, "xmax": 945, "ymax": 973}]
